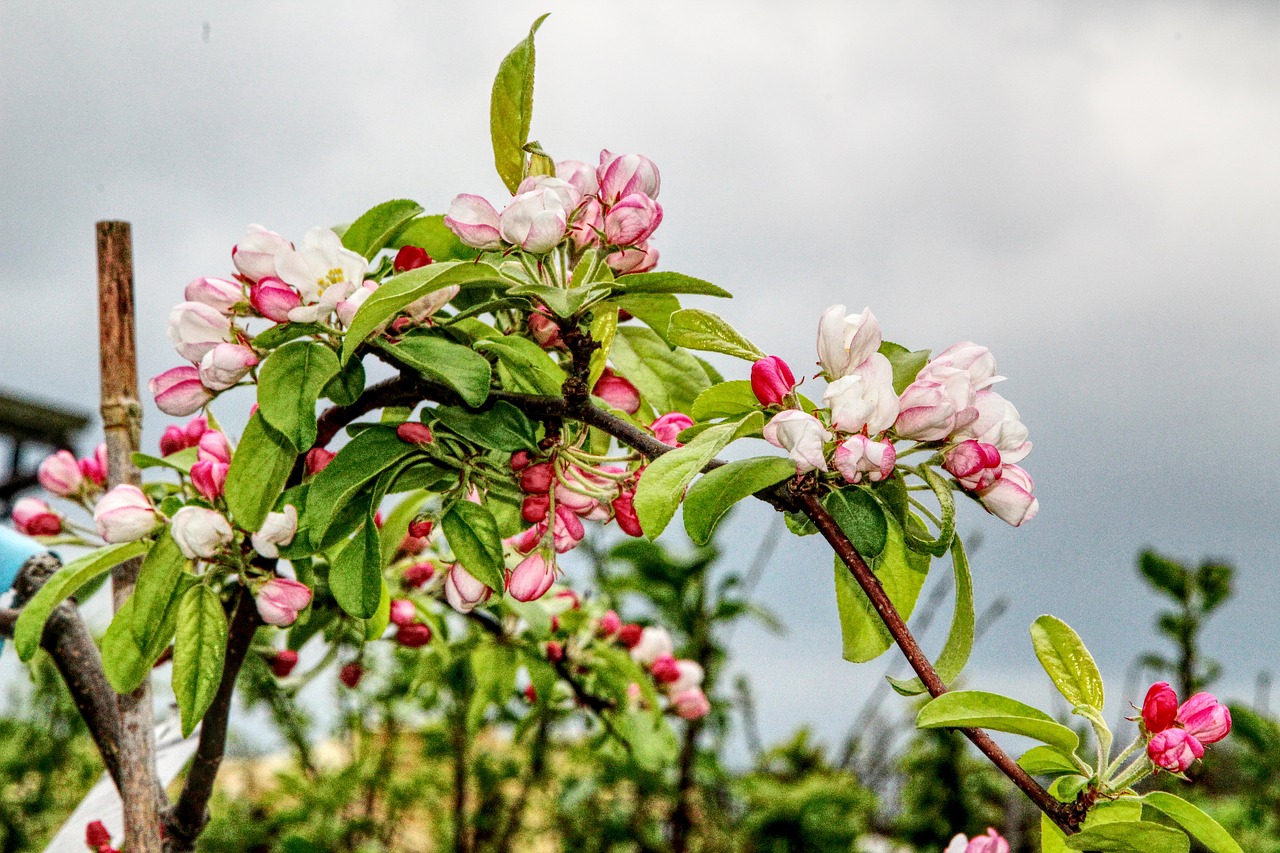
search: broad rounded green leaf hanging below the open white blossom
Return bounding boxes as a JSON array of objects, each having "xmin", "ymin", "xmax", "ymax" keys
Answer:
[{"xmin": 257, "ymin": 341, "xmax": 338, "ymax": 453}]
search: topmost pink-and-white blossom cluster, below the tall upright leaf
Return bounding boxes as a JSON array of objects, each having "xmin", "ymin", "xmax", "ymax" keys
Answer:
[{"xmin": 444, "ymin": 150, "xmax": 662, "ymax": 275}]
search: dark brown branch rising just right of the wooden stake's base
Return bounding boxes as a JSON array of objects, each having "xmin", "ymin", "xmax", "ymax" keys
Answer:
[{"xmin": 165, "ymin": 587, "xmax": 262, "ymax": 853}]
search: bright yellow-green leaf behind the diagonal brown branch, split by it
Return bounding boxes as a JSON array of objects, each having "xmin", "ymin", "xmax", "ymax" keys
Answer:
[{"xmin": 835, "ymin": 507, "xmax": 929, "ymax": 663}]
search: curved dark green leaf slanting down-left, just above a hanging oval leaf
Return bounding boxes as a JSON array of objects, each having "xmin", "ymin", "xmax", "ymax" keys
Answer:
[{"xmin": 299, "ymin": 425, "xmax": 416, "ymax": 544}]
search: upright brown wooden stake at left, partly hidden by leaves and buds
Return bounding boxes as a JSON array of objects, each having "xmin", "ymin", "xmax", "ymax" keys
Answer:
[{"xmin": 97, "ymin": 222, "xmax": 161, "ymax": 853}]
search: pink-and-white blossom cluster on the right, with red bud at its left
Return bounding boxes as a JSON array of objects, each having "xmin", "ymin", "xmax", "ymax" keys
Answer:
[{"xmin": 751, "ymin": 305, "xmax": 1039, "ymax": 526}]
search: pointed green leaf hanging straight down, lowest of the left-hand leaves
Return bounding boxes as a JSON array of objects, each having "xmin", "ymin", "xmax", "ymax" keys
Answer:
[{"xmin": 173, "ymin": 584, "xmax": 227, "ymax": 738}]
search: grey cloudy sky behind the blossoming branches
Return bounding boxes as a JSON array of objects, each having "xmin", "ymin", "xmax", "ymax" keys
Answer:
[{"xmin": 0, "ymin": 0, "xmax": 1280, "ymax": 753}]
